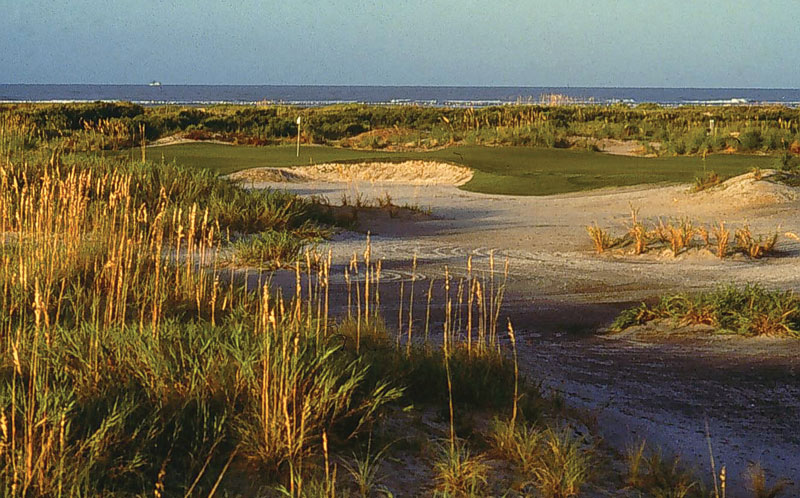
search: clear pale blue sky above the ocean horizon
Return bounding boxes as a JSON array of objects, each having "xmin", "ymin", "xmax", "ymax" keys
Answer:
[{"xmin": 0, "ymin": 0, "xmax": 800, "ymax": 88}]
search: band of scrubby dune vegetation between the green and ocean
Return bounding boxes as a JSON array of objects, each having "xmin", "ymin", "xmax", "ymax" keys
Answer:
[{"xmin": 6, "ymin": 103, "xmax": 800, "ymax": 155}]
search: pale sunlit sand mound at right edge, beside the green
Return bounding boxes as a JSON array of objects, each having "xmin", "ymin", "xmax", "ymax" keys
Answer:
[{"xmin": 692, "ymin": 169, "xmax": 800, "ymax": 205}]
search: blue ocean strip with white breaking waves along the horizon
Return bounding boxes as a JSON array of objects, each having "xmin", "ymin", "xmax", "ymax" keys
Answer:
[{"xmin": 0, "ymin": 84, "xmax": 800, "ymax": 107}]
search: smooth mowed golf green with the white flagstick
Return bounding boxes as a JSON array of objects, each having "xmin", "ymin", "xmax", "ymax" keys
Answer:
[{"xmin": 147, "ymin": 143, "xmax": 775, "ymax": 195}]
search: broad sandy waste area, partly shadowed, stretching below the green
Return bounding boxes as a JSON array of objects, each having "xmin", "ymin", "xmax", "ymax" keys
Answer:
[{"xmin": 241, "ymin": 172, "xmax": 800, "ymax": 496}]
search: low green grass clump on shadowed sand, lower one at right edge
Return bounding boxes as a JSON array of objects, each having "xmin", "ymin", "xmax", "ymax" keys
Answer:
[{"xmin": 611, "ymin": 285, "xmax": 800, "ymax": 337}]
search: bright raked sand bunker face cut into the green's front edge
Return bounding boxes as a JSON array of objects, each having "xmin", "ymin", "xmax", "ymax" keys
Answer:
[{"xmin": 230, "ymin": 161, "xmax": 472, "ymax": 185}]
